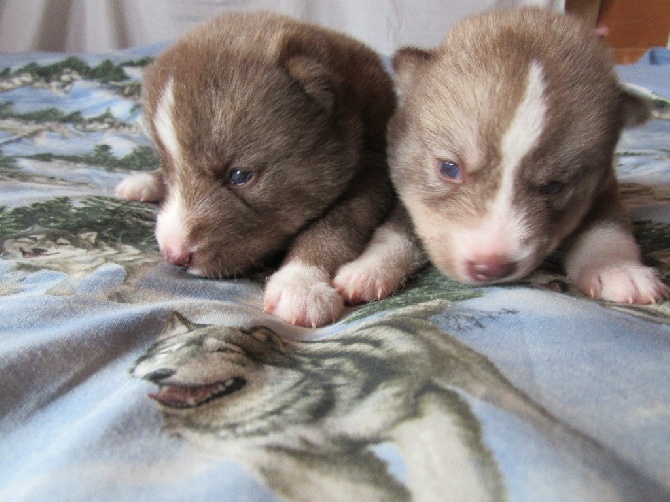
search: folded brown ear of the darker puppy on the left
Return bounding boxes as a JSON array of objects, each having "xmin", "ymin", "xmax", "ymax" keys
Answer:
[{"xmin": 276, "ymin": 33, "xmax": 341, "ymax": 113}]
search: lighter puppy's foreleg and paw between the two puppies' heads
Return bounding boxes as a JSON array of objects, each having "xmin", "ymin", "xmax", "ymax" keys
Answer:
[{"xmin": 333, "ymin": 202, "xmax": 426, "ymax": 304}]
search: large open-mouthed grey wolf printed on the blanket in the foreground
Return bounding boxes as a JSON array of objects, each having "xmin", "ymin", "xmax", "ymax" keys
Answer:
[{"xmin": 133, "ymin": 301, "xmax": 668, "ymax": 501}]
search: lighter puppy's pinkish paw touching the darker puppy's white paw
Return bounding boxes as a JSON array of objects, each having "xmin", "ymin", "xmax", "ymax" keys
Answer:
[{"xmin": 333, "ymin": 260, "xmax": 406, "ymax": 304}]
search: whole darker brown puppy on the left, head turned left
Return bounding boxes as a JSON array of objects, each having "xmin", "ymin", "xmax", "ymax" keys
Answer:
[{"xmin": 117, "ymin": 12, "xmax": 395, "ymax": 326}]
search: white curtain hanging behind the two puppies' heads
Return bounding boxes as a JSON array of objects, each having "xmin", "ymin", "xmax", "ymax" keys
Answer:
[{"xmin": 0, "ymin": 0, "xmax": 564, "ymax": 54}]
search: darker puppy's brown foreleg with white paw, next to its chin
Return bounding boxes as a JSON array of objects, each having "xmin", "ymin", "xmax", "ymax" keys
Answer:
[{"xmin": 264, "ymin": 163, "xmax": 393, "ymax": 327}]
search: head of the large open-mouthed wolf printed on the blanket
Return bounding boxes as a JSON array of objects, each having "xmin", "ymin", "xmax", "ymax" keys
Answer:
[{"xmin": 132, "ymin": 313, "xmax": 336, "ymax": 437}]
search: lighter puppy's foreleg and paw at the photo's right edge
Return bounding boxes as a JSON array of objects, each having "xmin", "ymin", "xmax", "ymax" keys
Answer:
[{"xmin": 565, "ymin": 190, "xmax": 668, "ymax": 304}]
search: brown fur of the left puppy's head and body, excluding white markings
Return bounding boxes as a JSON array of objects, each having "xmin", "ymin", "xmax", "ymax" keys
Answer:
[{"xmin": 145, "ymin": 10, "xmax": 394, "ymax": 276}]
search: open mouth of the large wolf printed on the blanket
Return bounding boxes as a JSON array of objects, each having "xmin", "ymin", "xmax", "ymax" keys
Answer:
[{"xmin": 149, "ymin": 377, "xmax": 247, "ymax": 409}]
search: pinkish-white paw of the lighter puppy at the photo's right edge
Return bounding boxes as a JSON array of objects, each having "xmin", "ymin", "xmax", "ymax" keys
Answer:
[{"xmin": 577, "ymin": 262, "xmax": 668, "ymax": 305}]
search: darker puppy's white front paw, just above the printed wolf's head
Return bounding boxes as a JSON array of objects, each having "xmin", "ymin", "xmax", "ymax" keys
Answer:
[{"xmin": 263, "ymin": 263, "xmax": 344, "ymax": 328}]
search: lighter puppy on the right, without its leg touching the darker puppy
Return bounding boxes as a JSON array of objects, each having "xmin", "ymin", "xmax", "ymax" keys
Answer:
[{"xmin": 380, "ymin": 9, "xmax": 666, "ymax": 304}]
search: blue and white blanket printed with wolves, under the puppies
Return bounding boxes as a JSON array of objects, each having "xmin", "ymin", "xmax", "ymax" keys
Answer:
[{"xmin": 0, "ymin": 48, "xmax": 670, "ymax": 501}]
